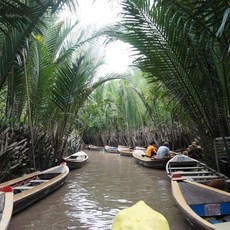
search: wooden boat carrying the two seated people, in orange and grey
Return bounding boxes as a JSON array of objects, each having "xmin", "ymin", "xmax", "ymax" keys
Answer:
[{"xmin": 132, "ymin": 150, "xmax": 171, "ymax": 169}]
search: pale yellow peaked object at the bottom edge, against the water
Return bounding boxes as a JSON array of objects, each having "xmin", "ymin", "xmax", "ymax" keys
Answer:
[{"xmin": 111, "ymin": 201, "xmax": 169, "ymax": 230}]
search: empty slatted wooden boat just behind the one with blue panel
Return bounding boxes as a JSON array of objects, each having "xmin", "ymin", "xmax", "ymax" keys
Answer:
[{"xmin": 166, "ymin": 154, "xmax": 228, "ymax": 188}]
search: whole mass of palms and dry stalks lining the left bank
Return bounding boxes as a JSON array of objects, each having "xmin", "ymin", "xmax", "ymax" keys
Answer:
[{"xmin": 0, "ymin": 0, "xmax": 121, "ymax": 179}]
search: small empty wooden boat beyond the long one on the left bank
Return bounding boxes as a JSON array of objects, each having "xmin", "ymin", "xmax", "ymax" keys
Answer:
[{"xmin": 63, "ymin": 151, "xmax": 89, "ymax": 169}]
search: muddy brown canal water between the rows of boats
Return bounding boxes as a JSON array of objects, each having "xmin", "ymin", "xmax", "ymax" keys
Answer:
[{"xmin": 8, "ymin": 150, "xmax": 192, "ymax": 230}]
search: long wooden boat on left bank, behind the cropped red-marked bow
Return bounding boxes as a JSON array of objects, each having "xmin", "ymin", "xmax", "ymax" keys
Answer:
[{"xmin": 0, "ymin": 162, "xmax": 69, "ymax": 214}]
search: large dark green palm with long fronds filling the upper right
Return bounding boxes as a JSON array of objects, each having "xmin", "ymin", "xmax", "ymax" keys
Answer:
[{"xmin": 104, "ymin": 0, "xmax": 230, "ymax": 154}]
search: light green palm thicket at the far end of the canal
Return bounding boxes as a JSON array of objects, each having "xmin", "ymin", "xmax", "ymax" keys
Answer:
[{"xmin": 79, "ymin": 68, "xmax": 190, "ymax": 148}]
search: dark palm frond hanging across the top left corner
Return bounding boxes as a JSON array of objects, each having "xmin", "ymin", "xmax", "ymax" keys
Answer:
[{"xmin": 0, "ymin": 0, "xmax": 78, "ymax": 89}]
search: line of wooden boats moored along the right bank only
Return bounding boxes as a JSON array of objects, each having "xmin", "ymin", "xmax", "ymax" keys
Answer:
[{"xmin": 91, "ymin": 146, "xmax": 230, "ymax": 230}]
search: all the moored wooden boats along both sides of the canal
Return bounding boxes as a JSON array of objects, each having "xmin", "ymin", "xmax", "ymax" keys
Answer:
[{"xmin": 0, "ymin": 146, "xmax": 230, "ymax": 230}]
